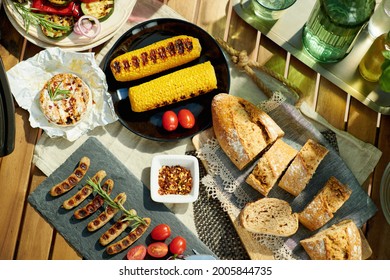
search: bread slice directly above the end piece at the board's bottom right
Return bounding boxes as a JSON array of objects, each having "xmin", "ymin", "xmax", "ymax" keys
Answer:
[{"xmin": 298, "ymin": 177, "xmax": 352, "ymax": 230}]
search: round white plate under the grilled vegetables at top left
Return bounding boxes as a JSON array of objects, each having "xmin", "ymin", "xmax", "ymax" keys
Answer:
[{"xmin": 4, "ymin": 0, "xmax": 137, "ymax": 51}]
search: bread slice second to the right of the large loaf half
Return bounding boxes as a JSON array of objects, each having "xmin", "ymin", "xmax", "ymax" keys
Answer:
[{"xmin": 279, "ymin": 139, "xmax": 329, "ymax": 196}]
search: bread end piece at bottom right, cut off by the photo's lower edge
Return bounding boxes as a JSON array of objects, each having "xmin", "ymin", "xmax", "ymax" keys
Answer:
[{"xmin": 300, "ymin": 220, "xmax": 362, "ymax": 260}]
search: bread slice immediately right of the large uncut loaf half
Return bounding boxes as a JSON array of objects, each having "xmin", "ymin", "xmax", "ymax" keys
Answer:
[{"xmin": 246, "ymin": 139, "xmax": 298, "ymax": 196}]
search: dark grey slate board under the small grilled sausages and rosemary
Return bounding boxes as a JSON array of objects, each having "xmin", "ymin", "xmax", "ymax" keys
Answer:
[{"xmin": 28, "ymin": 138, "xmax": 215, "ymax": 260}]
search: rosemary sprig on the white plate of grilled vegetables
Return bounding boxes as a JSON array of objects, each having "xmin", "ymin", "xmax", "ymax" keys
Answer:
[{"xmin": 12, "ymin": 2, "xmax": 72, "ymax": 34}]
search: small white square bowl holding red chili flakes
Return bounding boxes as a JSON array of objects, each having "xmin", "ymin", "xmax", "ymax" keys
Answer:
[{"xmin": 150, "ymin": 155, "xmax": 199, "ymax": 203}]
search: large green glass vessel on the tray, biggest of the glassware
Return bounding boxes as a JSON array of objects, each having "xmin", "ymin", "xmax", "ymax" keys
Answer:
[{"xmin": 303, "ymin": 0, "xmax": 375, "ymax": 63}]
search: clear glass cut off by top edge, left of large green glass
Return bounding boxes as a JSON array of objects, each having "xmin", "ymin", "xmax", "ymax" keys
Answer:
[{"xmin": 252, "ymin": 0, "xmax": 296, "ymax": 20}]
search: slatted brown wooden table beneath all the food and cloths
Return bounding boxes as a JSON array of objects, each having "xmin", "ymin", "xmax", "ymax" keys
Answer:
[{"xmin": 0, "ymin": 0, "xmax": 390, "ymax": 260}]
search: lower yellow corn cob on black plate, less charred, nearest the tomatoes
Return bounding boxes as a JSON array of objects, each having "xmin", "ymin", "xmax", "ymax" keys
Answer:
[{"xmin": 129, "ymin": 61, "xmax": 217, "ymax": 112}]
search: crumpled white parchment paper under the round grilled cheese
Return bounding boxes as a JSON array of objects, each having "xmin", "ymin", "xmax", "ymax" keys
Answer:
[{"xmin": 7, "ymin": 47, "xmax": 118, "ymax": 141}]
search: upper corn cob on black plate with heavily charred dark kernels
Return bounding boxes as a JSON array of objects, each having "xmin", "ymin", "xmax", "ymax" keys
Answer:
[{"xmin": 110, "ymin": 35, "xmax": 201, "ymax": 82}]
